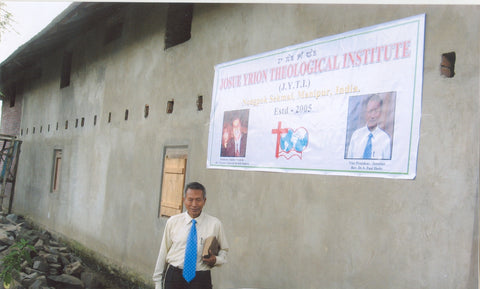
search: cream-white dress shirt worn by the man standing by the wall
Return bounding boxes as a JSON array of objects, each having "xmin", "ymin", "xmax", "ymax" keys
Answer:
[{"xmin": 153, "ymin": 212, "xmax": 228, "ymax": 289}]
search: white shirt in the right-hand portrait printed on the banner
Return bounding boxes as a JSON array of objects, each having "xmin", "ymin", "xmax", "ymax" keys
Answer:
[{"xmin": 347, "ymin": 126, "xmax": 391, "ymax": 160}]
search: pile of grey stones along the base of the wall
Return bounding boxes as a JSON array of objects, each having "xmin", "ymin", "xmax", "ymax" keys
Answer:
[{"xmin": 0, "ymin": 214, "xmax": 130, "ymax": 289}]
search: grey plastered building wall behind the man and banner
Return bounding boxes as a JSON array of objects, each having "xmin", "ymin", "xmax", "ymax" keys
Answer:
[{"xmin": 9, "ymin": 4, "xmax": 480, "ymax": 289}]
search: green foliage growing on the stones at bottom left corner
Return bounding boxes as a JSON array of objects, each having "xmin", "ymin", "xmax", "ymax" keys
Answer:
[{"xmin": 0, "ymin": 239, "xmax": 35, "ymax": 285}]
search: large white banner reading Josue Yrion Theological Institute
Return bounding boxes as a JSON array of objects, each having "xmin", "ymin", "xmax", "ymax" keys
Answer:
[{"xmin": 207, "ymin": 14, "xmax": 425, "ymax": 179}]
